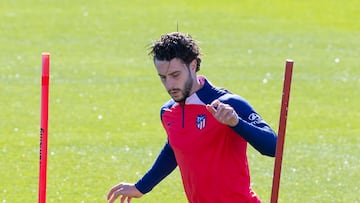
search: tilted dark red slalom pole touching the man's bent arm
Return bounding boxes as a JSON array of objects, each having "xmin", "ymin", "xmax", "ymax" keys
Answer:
[{"xmin": 270, "ymin": 59, "xmax": 294, "ymax": 203}]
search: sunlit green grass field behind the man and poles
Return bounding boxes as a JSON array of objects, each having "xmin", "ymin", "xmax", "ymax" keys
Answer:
[{"xmin": 0, "ymin": 0, "xmax": 360, "ymax": 203}]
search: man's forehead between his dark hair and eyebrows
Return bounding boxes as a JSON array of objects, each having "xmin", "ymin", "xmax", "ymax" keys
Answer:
[{"xmin": 154, "ymin": 58, "xmax": 186, "ymax": 75}]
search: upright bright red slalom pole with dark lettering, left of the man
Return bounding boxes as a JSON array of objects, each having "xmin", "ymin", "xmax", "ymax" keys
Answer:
[{"xmin": 39, "ymin": 53, "xmax": 50, "ymax": 203}]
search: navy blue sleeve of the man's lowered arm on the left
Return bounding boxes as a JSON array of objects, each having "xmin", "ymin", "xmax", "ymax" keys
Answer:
[{"xmin": 135, "ymin": 142, "xmax": 177, "ymax": 194}]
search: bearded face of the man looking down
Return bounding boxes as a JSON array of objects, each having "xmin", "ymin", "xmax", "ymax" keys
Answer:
[{"xmin": 154, "ymin": 58, "xmax": 198, "ymax": 102}]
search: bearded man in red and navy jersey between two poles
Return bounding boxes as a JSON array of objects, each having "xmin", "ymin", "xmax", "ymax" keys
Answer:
[{"xmin": 107, "ymin": 32, "xmax": 277, "ymax": 203}]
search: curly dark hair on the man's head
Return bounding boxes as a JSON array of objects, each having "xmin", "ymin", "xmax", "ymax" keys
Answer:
[{"xmin": 149, "ymin": 32, "xmax": 201, "ymax": 71}]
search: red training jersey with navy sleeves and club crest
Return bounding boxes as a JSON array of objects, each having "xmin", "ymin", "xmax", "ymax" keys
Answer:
[{"xmin": 135, "ymin": 76, "xmax": 277, "ymax": 203}]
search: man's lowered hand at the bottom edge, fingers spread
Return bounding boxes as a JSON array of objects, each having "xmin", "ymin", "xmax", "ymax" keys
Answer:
[{"xmin": 107, "ymin": 183, "xmax": 143, "ymax": 203}]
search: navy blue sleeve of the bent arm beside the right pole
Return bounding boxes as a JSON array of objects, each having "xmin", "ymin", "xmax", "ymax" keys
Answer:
[{"xmin": 219, "ymin": 94, "xmax": 277, "ymax": 157}]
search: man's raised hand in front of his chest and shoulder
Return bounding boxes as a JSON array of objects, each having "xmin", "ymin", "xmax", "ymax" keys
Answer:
[{"xmin": 206, "ymin": 99, "xmax": 239, "ymax": 127}]
